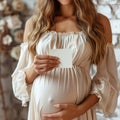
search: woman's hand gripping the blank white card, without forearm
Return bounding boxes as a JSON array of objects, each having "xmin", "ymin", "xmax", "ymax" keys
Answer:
[{"xmin": 33, "ymin": 55, "xmax": 60, "ymax": 74}]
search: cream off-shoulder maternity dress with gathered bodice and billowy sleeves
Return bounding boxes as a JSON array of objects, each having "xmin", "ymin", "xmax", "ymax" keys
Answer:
[{"xmin": 12, "ymin": 31, "xmax": 118, "ymax": 120}]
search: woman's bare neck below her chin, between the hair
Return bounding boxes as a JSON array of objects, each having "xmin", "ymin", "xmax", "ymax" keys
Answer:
[{"xmin": 60, "ymin": 4, "xmax": 74, "ymax": 17}]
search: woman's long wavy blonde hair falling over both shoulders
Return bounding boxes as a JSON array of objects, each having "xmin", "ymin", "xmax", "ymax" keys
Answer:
[{"xmin": 28, "ymin": 0, "xmax": 106, "ymax": 64}]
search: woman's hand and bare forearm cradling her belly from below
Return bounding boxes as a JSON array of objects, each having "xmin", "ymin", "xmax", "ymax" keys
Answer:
[{"xmin": 42, "ymin": 94, "xmax": 99, "ymax": 120}]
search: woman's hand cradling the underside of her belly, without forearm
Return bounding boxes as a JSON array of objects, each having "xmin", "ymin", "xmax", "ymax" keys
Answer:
[{"xmin": 42, "ymin": 104, "xmax": 79, "ymax": 120}]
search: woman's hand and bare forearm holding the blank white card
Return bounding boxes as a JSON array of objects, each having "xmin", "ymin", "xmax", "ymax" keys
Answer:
[{"xmin": 25, "ymin": 55, "xmax": 60, "ymax": 84}]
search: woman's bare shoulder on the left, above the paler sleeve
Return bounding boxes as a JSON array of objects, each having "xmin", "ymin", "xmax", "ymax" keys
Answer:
[{"xmin": 23, "ymin": 15, "xmax": 37, "ymax": 42}]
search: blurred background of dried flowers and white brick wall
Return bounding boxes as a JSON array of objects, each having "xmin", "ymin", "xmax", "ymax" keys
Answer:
[{"xmin": 0, "ymin": 0, "xmax": 120, "ymax": 120}]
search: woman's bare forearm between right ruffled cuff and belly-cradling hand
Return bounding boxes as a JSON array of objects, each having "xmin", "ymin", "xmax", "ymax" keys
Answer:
[{"xmin": 77, "ymin": 94, "xmax": 99, "ymax": 115}]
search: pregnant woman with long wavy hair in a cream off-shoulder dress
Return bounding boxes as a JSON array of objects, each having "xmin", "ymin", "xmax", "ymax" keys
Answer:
[{"xmin": 12, "ymin": 0, "xmax": 118, "ymax": 120}]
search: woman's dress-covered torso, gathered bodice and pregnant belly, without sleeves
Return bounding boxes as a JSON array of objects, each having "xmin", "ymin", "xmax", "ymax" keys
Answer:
[{"xmin": 31, "ymin": 31, "xmax": 92, "ymax": 113}]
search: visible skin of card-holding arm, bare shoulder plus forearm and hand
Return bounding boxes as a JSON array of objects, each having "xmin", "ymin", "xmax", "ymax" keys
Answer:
[{"xmin": 24, "ymin": 16, "xmax": 60, "ymax": 84}]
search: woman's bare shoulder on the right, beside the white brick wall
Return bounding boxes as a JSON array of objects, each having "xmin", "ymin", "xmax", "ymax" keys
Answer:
[{"xmin": 98, "ymin": 13, "xmax": 112, "ymax": 43}]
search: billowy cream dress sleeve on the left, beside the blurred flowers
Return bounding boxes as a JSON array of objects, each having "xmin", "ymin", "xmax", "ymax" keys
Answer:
[{"xmin": 11, "ymin": 43, "xmax": 32, "ymax": 106}]
